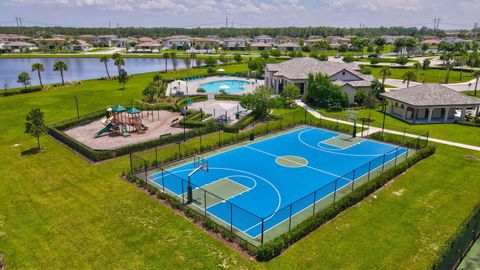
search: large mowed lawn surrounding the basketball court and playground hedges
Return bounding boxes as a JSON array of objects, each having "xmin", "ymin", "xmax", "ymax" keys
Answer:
[{"xmin": 0, "ymin": 69, "xmax": 480, "ymax": 269}]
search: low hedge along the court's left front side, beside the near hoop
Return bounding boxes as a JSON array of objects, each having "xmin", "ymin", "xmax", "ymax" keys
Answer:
[{"xmin": 126, "ymin": 173, "xmax": 255, "ymax": 255}]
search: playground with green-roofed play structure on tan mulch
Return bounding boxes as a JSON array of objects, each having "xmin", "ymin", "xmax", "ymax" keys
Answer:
[{"xmin": 65, "ymin": 105, "xmax": 188, "ymax": 150}]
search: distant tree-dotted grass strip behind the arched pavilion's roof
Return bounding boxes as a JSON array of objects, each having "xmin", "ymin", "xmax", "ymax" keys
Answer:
[{"xmin": 372, "ymin": 67, "xmax": 473, "ymax": 83}]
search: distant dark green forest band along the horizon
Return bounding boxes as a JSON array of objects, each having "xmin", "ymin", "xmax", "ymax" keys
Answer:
[{"xmin": 0, "ymin": 26, "xmax": 445, "ymax": 38}]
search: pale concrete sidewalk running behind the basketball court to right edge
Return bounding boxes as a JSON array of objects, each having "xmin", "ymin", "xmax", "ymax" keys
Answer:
[{"xmin": 295, "ymin": 100, "xmax": 480, "ymax": 151}]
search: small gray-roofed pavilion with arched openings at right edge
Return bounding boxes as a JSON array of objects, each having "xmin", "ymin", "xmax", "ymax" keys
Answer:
[{"xmin": 382, "ymin": 83, "xmax": 480, "ymax": 124}]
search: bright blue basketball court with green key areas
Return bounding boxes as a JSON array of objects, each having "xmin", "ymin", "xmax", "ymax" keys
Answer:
[{"xmin": 148, "ymin": 127, "xmax": 407, "ymax": 245}]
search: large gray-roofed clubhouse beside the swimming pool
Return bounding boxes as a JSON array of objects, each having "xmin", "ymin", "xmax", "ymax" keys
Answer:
[{"xmin": 265, "ymin": 57, "xmax": 374, "ymax": 103}]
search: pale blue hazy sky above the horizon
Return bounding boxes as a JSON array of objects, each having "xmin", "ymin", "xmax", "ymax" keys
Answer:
[{"xmin": 0, "ymin": 0, "xmax": 480, "ymax": 29}]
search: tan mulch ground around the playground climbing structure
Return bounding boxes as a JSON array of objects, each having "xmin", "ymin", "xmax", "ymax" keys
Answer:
[{"xmin": 65, "ymin": 111, "xmax": 188, "ymax": 150}]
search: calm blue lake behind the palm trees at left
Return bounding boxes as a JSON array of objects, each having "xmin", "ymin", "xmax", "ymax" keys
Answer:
[{"xmin": 0, "ymin": 58, "xmax": 203, "ymax": 89}]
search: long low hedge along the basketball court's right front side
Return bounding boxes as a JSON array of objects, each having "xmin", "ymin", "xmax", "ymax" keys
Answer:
[{"xmin": 255, "ymin": 146, "xmax": 436, "ymax": 261}]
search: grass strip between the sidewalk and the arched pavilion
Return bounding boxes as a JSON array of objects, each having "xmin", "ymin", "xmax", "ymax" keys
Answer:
[{"xmin": 318, "ymin": 107, "xmax": 480, "ymax": 146}]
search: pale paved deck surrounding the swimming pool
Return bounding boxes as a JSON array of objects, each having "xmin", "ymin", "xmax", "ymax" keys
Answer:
[{"xmin": 167, "ymin": 76, "xmax": 264, "ymax": 96}]
